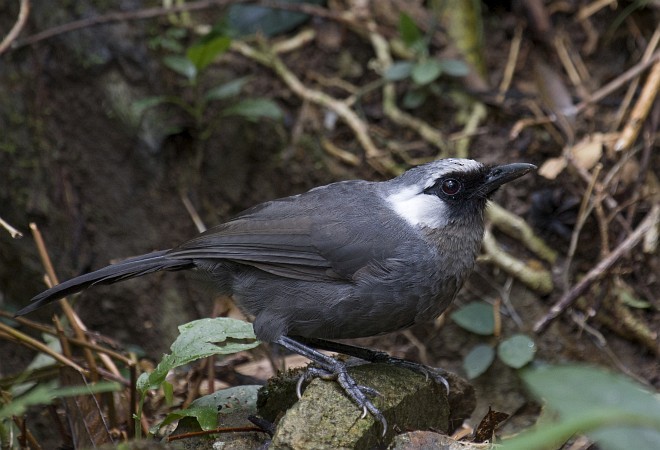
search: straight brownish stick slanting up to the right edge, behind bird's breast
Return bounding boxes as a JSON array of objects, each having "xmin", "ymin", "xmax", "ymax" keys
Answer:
[{"xmin": 534, "ymin": 204, "xmax": 660, "ymax": 333}]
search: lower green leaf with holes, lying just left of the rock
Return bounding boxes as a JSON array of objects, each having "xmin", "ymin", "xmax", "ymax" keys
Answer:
[{"xmin": 151, "ymin": 385, "xmax": 261, "ymax": 434}]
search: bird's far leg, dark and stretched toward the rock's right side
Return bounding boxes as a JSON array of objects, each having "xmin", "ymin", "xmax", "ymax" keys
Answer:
[{"xmin": 294, "ymin": 336, "xmax": 449, "ymax": 394}]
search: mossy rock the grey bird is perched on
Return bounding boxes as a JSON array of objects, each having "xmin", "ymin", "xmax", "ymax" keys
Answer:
[{"xmin": 258, "ymin": 364, "xmax": 475, "ymax": 449}]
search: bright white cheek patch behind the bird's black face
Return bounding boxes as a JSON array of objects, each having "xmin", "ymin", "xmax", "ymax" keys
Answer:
[{"xmin": 385, "ymin": 186, "xmax": 447, "ymax": 228}]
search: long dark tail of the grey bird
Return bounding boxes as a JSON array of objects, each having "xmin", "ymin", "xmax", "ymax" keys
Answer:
[{"xmin": 16, "ymin": 250, "xmax": 194, "ymax": 316}]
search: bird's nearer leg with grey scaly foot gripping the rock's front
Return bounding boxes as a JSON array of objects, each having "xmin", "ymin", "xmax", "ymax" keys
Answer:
[{"xmin": 275, "ymin": 336, "xmax": 387, "ymax": 436}]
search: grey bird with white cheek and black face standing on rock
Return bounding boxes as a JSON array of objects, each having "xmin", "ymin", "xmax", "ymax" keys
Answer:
[{"xmin": 16, "ymin": 158, "xmax": 536, "ymax": 434}]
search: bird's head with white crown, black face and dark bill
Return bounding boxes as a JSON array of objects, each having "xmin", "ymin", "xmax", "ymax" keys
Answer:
[{"xmin": 385, "ymin": 159, "xmax": 536, "ymax": 229}]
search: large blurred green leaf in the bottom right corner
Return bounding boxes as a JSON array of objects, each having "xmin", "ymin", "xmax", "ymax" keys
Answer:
[{"xmin": 503, "ymin": 366, "xmax": 660, "ymax": 450}]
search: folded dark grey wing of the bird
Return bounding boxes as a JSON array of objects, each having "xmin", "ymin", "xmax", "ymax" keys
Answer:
[{"xmin": 167, "ymin": 181, "xmax": 410, "ymax": 281}]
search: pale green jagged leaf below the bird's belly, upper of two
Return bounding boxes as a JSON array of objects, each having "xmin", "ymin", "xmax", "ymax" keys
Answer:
[{"xmin": 137, "ymin": 317, "xmax": 259, "ymax": 394}]
